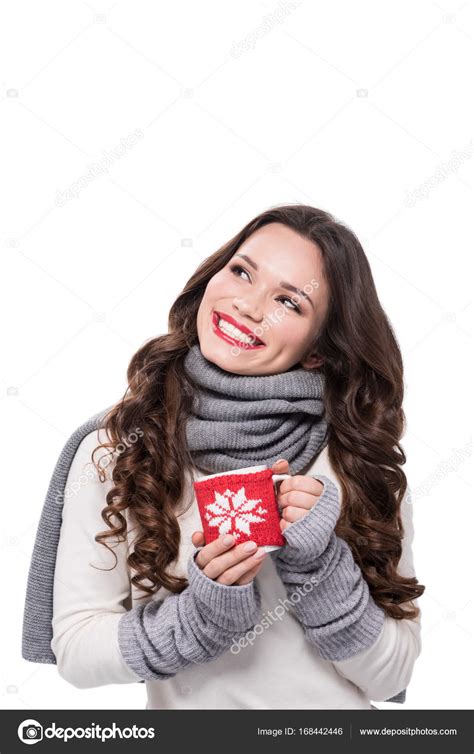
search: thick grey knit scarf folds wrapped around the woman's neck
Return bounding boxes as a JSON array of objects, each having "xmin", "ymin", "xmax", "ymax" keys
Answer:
[{"xmin": 184, "ymin": 344, "xmax": 327, "ymax": 474}]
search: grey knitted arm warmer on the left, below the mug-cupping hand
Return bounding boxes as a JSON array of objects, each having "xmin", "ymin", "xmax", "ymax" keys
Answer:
[{"xmin": 118, "ymin": 548, "xmax": 261, "ymax": 680}]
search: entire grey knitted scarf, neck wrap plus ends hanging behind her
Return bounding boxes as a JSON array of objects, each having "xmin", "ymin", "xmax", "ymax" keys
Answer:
[{"xmin": 22, "ymin": 345, "xmax": 404, "ymax": 702}]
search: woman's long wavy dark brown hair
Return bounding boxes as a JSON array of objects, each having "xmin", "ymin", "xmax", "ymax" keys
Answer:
[{"xmin": 92, "ymin": 204, "xmax": 425, "ymax": 619}]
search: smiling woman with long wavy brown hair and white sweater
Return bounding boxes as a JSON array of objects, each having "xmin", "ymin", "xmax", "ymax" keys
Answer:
[{"xmin": 44, "ymin": 205, "xmax": 424, "ymax": 709}]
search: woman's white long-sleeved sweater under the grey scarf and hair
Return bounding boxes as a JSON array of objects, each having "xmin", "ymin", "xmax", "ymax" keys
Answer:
[{"xmin": 51, "ymin": 429, "xmax": 421, "ymax": 709}]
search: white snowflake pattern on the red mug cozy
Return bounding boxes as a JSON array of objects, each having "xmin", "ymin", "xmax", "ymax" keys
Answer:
[{"xmin": 205, "ymin": 487, "xmax": 267, "ymax": 539}]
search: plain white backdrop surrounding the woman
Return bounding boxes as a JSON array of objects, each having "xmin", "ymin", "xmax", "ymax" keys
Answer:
[{"xmin": 0, "ymin": 0, "xmax": 473, "ymax": 710}]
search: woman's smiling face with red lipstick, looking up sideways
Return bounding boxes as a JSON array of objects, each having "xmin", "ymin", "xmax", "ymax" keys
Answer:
[{"xmin": 197, "ymin": 223, "xmax": 329, "ymax": 375}]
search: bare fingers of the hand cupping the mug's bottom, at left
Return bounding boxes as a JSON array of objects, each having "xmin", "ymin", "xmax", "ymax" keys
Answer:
[{"xmin": 192, "ymin": 531, "xmax": 267, "ymax": 586}]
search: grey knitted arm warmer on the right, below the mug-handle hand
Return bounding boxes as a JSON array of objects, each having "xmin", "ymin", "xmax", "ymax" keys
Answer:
[{"xmin": 271, "ymin": 474, "xmax": 385, "ymax": 661}]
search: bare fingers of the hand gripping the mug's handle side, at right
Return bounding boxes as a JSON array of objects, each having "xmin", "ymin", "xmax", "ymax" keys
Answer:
[{"xmin": 271, "ymin": 459, "xmax": 324, "ymax": 531}]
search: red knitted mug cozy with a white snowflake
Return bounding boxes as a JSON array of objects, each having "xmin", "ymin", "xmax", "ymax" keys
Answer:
[{"xmin": 193, "ymin": 469, "xmax": 285, "ymax": 546}]
